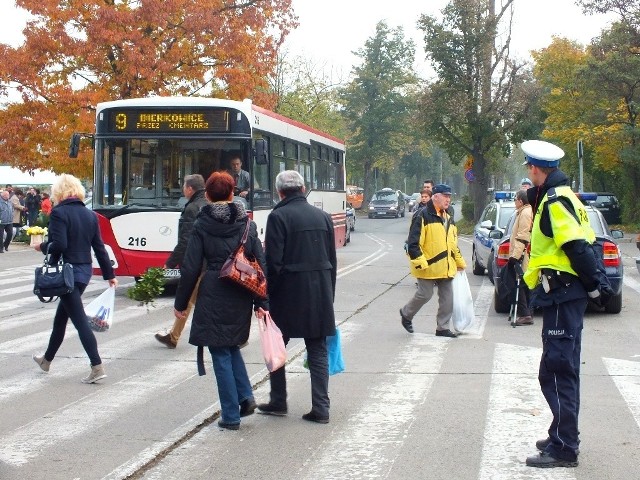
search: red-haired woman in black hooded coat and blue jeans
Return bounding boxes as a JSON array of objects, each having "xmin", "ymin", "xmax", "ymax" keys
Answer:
[{"xmin": 174, "ymin": 172, "xmax": 269, "ymax": 430}]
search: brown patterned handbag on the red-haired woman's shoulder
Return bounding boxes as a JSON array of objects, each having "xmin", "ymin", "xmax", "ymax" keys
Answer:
[{"xmin": 219, "ymin": 217, "xmax": 267, "ymax": 298}]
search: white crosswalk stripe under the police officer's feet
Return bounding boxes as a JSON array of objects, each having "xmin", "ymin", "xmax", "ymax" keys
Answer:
[{"xmin": 478, "ymin": 344, "xmax": 576, "ymax": 480}]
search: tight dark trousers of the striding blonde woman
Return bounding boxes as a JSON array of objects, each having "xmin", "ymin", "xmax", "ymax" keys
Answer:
[{"xmin": 44, "ymin": 282, "xmax": 102, "ymax": 367}]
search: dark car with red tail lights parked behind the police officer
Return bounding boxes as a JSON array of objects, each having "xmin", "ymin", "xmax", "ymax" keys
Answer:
[{"xmin": 492, "ymin": 205, "xmax": 624, "ymax": 313}]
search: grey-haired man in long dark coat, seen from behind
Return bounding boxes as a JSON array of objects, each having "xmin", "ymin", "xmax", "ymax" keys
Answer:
[{"xmin": 258, "ymin": 170, "xmax": 337, "ymax": 423}]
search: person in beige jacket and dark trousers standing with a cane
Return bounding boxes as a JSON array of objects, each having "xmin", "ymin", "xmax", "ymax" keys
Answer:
[{"xmin": 508, "ymin": 190, "xmax": 533, "ymax": 326}]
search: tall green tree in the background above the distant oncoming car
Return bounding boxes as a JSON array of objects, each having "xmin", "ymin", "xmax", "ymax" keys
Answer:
[{"xmin": 341, "ymin": 22, "xmax": 417, "ymax": 198}]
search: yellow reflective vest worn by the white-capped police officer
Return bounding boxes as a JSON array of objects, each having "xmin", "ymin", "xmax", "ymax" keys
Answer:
[{"xmin": 524, "ymin": 186, "xmax": 596, "ymax": 289}]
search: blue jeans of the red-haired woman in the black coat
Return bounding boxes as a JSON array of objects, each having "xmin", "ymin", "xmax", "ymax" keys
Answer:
[{"xmin": 209, "ymin": 346, "xmax": 253, "ymax": 424}]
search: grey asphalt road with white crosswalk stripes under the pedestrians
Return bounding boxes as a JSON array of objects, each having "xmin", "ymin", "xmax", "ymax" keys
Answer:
[{"xmin": 0, "ymin": 217, "xmax": 640, "ymax": 480}]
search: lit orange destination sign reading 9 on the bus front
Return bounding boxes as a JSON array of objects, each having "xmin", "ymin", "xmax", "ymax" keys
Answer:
[{"xmin": 109, "ymin": 110, "xmax": 229, "ymax": 133}]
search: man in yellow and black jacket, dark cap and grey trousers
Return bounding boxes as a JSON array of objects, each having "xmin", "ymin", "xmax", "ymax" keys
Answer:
[{"xmin": 400, "ymin": 184, "xmax": 466, "ymax": 338}]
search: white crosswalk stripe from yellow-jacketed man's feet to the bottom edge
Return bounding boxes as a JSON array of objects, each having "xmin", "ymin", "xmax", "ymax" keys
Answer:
[{"xmin": 299, "ymin": 336, "xmax": 449, "ymax": 480}]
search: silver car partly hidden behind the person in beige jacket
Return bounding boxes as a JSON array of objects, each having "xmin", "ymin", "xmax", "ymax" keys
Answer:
[{"xmin": 471, "ymin": 192, "xmax": 516, "ymax": 278}]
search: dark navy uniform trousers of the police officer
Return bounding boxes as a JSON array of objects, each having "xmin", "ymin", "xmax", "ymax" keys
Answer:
[{"xmin": 538, "ymin": 298, "xmax": 587, "ymax": 461}]
